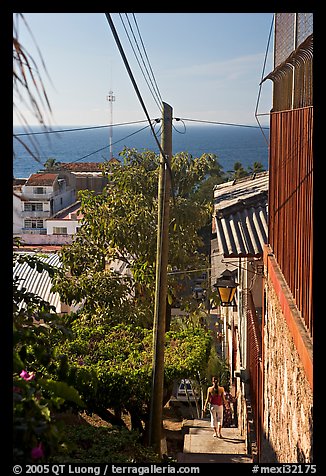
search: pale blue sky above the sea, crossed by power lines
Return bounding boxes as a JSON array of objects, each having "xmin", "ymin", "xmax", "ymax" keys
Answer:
[{"xmin": 14, "ymin": 13, "xmax": 273, "ymax": 125}]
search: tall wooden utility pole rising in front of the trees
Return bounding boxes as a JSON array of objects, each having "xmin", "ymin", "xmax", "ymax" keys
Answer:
[{"xmin": 149, "ymin": 102, "xmax": 172, "ymax": 456}]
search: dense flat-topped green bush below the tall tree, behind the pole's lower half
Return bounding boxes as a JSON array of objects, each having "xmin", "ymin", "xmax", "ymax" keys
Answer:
[{"xmin": 52, "ymin": 319, "xmax": 210, "ymax": 419}]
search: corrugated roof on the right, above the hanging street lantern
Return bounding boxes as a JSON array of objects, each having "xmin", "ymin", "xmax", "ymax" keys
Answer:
[{"xmin": 214, "ymin": 172, "xmax": 268, "ymax": 258}]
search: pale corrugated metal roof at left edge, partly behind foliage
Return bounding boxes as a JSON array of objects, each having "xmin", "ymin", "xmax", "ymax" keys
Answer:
[{"xmin": 13, "ymin": 252, "xmax": 62, "ymax": 312}]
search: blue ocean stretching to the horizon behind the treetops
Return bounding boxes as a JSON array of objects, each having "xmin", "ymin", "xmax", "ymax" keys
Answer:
[{"xmin": 13, "ymin": 121, "xmax": 269, "ymax": 178}]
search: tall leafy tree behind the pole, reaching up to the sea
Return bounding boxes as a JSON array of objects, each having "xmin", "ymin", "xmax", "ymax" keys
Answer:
[{"xmin": 56, "ymin": 149, "xmax": 223, "ymax": 327}]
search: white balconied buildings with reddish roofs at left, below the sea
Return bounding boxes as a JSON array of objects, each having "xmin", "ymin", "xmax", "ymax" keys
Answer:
[{"xmin": 13, "ymin": 163, "xmax": 109, "ymax": 246}]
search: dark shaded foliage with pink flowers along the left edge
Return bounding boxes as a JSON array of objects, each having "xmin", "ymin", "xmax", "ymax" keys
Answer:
[{"xmin": 13, "ymin": 254, "xmax": 82, "ymax": 463}]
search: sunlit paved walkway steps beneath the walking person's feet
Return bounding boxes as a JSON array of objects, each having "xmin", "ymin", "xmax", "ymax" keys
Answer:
[{"xmin": 177, "ymin": 419, "xmax": 253, "ymax": 463}]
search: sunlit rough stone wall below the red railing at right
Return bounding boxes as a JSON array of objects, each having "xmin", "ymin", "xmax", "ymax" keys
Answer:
[{"xmin": 260, "ymin": 282, "xmax": 313, "ymax": 463}]
